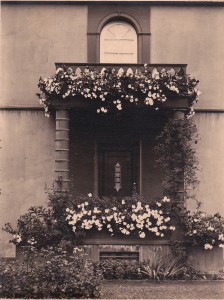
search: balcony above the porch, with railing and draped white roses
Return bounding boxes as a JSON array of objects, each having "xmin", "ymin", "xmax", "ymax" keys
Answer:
[{"xmin": 41, "ymin": 63, "xmax": 197, "ymax": 112}]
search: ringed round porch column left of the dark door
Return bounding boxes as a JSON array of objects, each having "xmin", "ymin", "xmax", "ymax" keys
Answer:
[{"xmin": 55, "ymin": 109, "xmax": 69, "ymax": 193}]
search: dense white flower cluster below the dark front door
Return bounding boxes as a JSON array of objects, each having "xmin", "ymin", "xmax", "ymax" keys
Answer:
[{"xmin": 66, "ymin": 197, "xmax": 175, "ymax": 238}]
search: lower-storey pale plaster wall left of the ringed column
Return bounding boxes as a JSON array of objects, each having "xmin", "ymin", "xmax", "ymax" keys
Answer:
[{"xmin": 0, "ymin": 111, "xmax": 55, "ymax": 256}]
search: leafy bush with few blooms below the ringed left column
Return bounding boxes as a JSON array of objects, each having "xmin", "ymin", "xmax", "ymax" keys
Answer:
[{"xmin": 3, "ymin": 191, "xmax": 88, "ymax": 250}]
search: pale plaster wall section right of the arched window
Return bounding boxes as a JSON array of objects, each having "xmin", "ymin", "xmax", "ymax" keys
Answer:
[{"xmin": 150, "ymin": 6, "xmax": 224, "ymax": 109}]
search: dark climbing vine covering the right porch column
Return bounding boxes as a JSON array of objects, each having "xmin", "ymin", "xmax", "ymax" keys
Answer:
[{"xmin": 155, "ymin": 118, "xmax": 198, "ymax": 202}]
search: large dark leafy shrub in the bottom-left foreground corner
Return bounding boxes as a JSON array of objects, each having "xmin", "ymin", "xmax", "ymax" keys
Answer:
[{"xmin": 0, "ymin": 245, "xmax": 100, "ymax": 298}]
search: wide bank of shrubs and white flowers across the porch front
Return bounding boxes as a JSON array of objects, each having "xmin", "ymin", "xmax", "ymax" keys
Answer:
[{"xmin": 4, "ymin": 193, "xmax": 224, "ymax": 250}]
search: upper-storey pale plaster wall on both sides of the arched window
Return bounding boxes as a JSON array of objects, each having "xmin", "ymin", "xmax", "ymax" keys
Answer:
[{"xmin": 1, "ymin": 4, "xmax": 224, "ymax": 109}]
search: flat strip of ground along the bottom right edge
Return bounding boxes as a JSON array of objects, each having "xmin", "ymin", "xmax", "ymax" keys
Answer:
[{"xmin": 101, "ymin": 280, "xmax": 224, "ymax": 299}]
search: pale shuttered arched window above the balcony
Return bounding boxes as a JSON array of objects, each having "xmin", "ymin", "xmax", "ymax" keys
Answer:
[{"xmin": 100, "ymin": 21, "xmax": 137, "ymax": 63}]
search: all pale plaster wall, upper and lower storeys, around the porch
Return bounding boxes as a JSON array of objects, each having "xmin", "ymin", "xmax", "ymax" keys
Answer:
[{"xmin": 0, "ymin": 4, "xmax": 224, "ymax": 256}]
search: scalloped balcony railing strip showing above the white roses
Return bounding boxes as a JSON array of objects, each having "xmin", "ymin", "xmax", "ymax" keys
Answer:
[{"xmin": 55, "ymin": 63, "xmax": 187, "ymax": 76}]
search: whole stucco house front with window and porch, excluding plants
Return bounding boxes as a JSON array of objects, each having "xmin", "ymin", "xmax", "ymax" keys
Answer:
[{"xmin": 0, "ymin": 1, "xmax": 224, "ymax": 272}]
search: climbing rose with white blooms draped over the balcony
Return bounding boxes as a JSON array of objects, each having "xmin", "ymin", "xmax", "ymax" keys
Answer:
[{"xmin": 37, "ymin": 64, "xmax": 200, "ymax": 116}]
